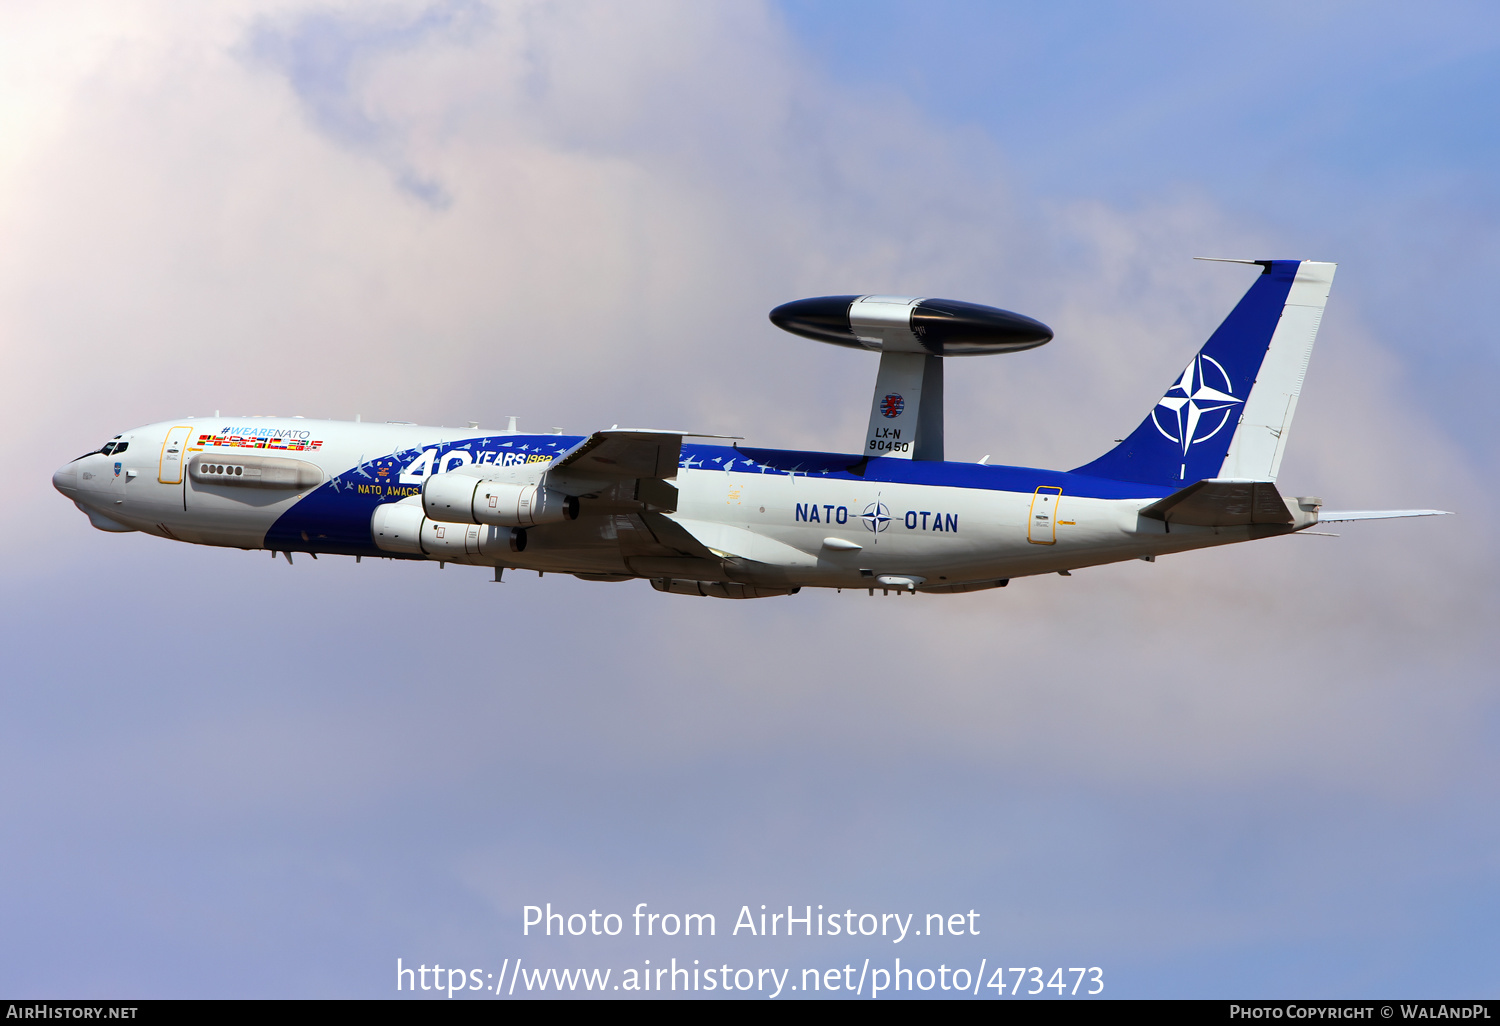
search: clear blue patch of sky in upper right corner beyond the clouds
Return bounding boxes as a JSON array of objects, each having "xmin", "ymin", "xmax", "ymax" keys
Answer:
[{"xmin": 782, "ymin": 0, "xmax": 1500, "ymax": 461}]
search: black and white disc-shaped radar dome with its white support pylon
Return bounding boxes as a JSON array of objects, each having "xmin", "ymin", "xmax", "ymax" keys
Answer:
[{"xmin": 771, "ymin": 296, "xmax": 1052, "ymax": 461}]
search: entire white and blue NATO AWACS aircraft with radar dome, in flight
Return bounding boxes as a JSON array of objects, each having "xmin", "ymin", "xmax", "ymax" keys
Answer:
[{"xmin": 53, "ymin": 260, "xmax": 1440, "ymax": 599}]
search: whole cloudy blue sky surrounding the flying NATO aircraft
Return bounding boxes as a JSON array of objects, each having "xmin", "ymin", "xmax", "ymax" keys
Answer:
[{"xmin": 0, "ymin": 2, "xmax": 1500, "ymax": 998}]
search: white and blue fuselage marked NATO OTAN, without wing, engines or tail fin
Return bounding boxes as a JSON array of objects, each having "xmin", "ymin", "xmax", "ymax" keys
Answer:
[{"xmin": 54, "ymin": 419, "xmax": 1307, "ymax": 590}]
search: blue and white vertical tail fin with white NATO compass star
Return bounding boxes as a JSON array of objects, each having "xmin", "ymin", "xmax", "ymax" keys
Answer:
[{"xmin": 1074, "ymin": 260, "xmax": 1335, "ymax": 486}]
